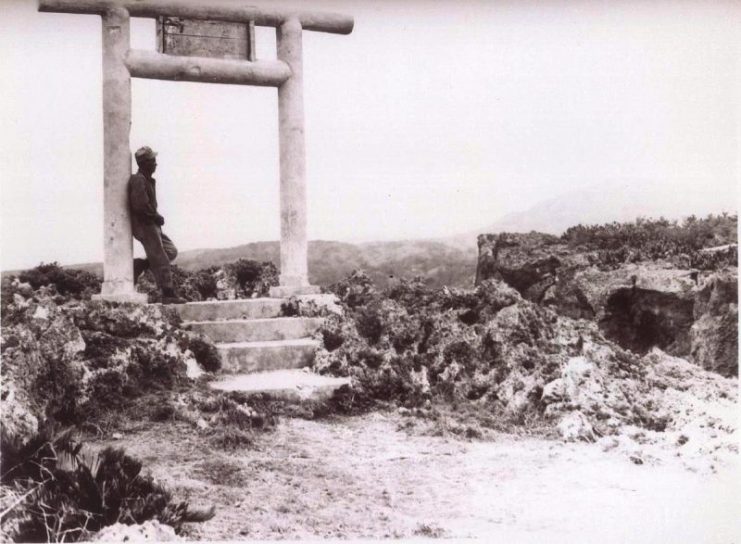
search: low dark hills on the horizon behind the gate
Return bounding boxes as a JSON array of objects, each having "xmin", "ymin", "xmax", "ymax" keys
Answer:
[{"xmin": 55, "ymin": 239, "xmax": 477, "ymax": 287}]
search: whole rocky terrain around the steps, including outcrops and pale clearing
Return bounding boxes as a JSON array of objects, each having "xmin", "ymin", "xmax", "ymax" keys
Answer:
[{"xmin": 0, "ymin": 224, "xmax": 741, "ymax": 542}]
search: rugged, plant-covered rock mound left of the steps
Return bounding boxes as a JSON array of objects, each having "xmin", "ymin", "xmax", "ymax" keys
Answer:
[{"xmin": 0, "ymin": 280, "xmax": 218, "ymax": 439}]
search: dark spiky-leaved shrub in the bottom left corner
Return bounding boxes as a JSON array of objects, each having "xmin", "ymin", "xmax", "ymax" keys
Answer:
[{"xmin": 0, "ymin": 431, "xmax": 213, "ymax": 542}]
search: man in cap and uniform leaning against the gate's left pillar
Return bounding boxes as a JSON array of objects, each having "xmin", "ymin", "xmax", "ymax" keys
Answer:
[{"xmin": 129, "ymin": 146, "xmax": 185, "ymax": 304}]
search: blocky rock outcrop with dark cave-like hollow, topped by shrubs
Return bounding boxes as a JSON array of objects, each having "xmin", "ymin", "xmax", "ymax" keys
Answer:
[{"xmin": 477, "ymin": 233, "xmax": 738, "ymax": 376}]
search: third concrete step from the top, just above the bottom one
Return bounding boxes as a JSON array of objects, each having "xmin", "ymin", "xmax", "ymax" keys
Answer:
[{"xmin": 216, "ymin": 338, "xmax": 319, "ymax": 374}]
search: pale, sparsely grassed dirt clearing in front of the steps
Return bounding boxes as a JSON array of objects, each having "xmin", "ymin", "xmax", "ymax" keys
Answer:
[{"xmin": 100, "ymin": 413, "xmax": 741, "ymax": 543}]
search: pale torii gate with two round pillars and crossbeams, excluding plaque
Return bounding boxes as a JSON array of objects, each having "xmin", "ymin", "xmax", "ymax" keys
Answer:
[{"xmin": 39, "ymin": 0, "xmax": 354, "ymax": 303}]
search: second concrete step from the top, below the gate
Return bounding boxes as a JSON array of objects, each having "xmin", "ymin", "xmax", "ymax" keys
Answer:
[{"xmin": 186, "ymin": 317, "xmax": 324, "ymax": 342}]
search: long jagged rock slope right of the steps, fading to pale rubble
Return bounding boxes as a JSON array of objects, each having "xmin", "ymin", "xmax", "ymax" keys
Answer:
[{"xmin": 314, "ymin": 276, "xmax": 737, "ymax": 462}]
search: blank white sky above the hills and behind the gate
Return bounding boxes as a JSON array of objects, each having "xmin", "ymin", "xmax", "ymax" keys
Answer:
[{"xmin": 0, "ymin": 0, "xmax": 741, "ymax": 269}]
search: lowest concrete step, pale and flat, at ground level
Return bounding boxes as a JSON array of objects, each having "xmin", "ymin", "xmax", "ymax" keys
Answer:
[{"xmin": 209, "ymin": 370, "xmax": 350, "ymax": 400}]
